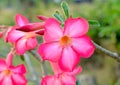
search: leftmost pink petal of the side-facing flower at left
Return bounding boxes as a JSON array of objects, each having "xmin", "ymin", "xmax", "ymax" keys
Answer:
[{"xmin": 7, "ymin": 30, "xmax": 25, "ymax": 43}]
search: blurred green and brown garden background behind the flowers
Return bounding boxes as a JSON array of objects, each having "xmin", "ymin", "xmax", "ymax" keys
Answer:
[{"xmin": 0, "ymin": 0, "xmax": 120, "ymax": 85}]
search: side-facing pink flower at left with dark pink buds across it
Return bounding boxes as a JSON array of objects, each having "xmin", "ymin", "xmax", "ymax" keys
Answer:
[{"xmin": 5, "ymin": 14, "xmax": 44, "ymax": 55}]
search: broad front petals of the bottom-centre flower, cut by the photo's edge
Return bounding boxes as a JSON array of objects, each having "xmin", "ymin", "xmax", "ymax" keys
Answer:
[{"xmin": 41, "ymin": 74, "xmax": 76, "ymax": 85}]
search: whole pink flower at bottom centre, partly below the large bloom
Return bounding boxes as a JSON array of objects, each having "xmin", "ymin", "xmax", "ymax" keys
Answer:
[{"xmin": 41, "ymin": 63, "xmax": 82, "ymax": 85}]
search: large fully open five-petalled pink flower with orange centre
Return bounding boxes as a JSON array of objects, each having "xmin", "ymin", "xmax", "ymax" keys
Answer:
[{"xmin": 38, "ymin": 18, "xmax": 95, "ymax": 71}]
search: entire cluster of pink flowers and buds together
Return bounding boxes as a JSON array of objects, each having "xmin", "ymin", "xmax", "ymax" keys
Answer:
[{"xmin": 0, "ymin": 14, "xmax": 95, "ymax": 85}]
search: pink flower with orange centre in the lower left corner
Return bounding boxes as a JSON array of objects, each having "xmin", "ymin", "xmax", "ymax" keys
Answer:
[{"xmin": 0, "ymin": 53, "xmax": 27, "ymax": 85}]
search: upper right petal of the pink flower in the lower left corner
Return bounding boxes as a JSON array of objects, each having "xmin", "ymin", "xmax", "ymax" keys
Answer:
[{"xmin": 10, "ymin": 64, "xmax": 26, "ymax": 74}]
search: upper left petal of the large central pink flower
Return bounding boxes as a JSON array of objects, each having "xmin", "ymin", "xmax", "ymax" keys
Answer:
[{"xmin": 44, "ymin": 18, "xmax": 63, "ymax": 42}]
